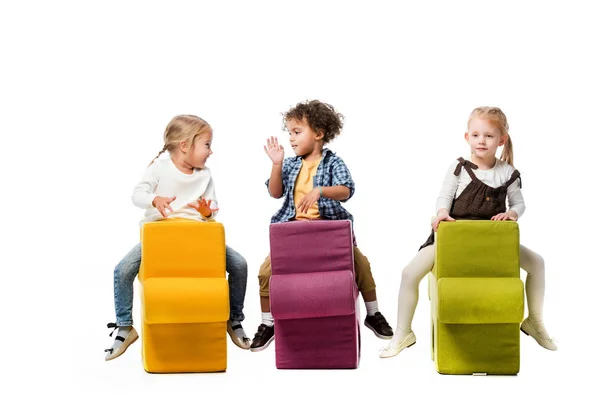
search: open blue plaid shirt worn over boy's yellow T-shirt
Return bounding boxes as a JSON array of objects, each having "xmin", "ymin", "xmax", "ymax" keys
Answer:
[{"xmin": 265, "ymin": 149, "xmax": 354, "ymax": 223}]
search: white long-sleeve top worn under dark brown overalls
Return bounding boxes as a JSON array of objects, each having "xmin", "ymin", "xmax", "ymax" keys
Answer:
[{"xmin": 435, "ymin": 157, "xmax": 525, "ymax": 218}]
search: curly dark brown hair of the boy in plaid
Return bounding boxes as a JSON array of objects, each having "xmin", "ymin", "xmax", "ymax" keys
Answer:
[{"xmin": 282, "ymin": 100, "xmax": 344, "ymax": 144}]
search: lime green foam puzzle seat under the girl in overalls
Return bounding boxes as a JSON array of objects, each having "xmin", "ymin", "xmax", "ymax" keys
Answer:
[{"xmin": 429, "ymin": 220, "xmax": 524, "ymax": 375}]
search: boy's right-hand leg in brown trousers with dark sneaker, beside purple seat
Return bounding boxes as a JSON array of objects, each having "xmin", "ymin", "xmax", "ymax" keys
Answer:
[{"xmin": 354, "ymin": 247, "xmax": 394, "ymax": 339}]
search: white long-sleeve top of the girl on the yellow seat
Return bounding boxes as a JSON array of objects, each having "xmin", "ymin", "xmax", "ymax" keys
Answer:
[{"xmin": 131, "ymin": 158, "xmax": 218, "ymax": 225}]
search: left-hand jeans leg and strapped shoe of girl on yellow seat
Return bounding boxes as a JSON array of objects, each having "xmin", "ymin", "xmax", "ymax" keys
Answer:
[{"xmin": 104, "ymin": 243, "xmax": 142, "ymax": 361}]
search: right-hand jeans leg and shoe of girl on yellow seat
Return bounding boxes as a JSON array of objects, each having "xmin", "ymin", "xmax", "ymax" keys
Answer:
[{"xmin": 225, "ymin": 246, "xmax": 250, "ymax": 350}]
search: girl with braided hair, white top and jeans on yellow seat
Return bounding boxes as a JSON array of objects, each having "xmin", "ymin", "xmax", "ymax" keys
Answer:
[{"xmin": 105, "ymin": 115, "xmax": 250, "ymax": 361}]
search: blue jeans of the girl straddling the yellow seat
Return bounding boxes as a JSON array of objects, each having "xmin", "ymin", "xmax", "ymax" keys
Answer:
[{"xmin": 115, "ymin": 243, "xmax": 248, "ymax": 326}]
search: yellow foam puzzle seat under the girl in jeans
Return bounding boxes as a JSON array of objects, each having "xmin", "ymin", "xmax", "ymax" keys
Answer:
[{"xmin": 138, "ymin": 219, "xmax": 229, "ymax": 373}]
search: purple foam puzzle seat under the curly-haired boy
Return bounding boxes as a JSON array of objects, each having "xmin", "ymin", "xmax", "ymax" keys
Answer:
[{"xmin": 270, "ymin": 220, "xmax": 360, "ymax": 369}]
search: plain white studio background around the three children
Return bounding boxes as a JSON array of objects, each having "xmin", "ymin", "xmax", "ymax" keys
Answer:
[{"xmin": 0, "ymin": 1, "xmax": 600, "ymax": 399}]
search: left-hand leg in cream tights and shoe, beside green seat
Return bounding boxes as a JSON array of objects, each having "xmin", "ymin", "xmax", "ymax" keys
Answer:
[{"xmin": 379, "ymin": 246, "xmax": 435, "ymax": 358}]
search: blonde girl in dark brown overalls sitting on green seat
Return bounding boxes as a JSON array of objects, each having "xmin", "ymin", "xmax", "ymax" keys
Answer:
[{"xmin": 379, "ymin": 107, "xmax": 557, "ymax": 358}]
